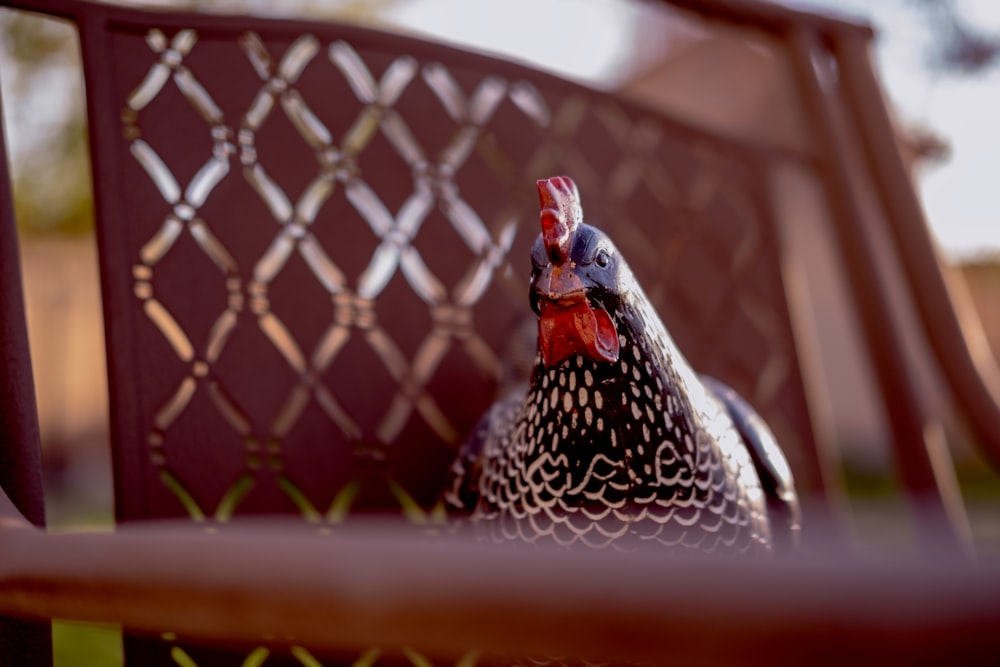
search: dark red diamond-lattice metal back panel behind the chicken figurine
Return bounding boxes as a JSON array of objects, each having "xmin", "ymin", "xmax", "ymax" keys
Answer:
[{"xmin": 95, "ymin": 24, "xmax": 814, "ymax": 521}]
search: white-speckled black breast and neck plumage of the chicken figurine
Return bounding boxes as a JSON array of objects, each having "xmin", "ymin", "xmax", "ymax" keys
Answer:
[{"xmin": 446, "ymin": 280, "xmax": 769, "ymax": 552}]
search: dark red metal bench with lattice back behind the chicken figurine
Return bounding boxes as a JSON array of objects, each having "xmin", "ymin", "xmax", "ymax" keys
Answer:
[{"xmin": 0, "ymin": 0, "xmax": 1000, "ymax": 665}]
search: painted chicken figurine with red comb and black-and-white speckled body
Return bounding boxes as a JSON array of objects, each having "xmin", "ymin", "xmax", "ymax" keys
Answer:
[{"xmin": 444, "ymin": 176, "xmax": 800, "ymax": 553}]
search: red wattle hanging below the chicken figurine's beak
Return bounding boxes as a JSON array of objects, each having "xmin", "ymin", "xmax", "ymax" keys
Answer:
[{"xmin": 538, "ymin": 299, "xmax": 619, "ymax": 367}]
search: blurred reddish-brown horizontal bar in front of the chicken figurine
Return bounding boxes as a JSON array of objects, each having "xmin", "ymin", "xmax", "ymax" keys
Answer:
[{"xmin": 0, "ymin": 508, "xmax": 1000, "ymax": 664}]
